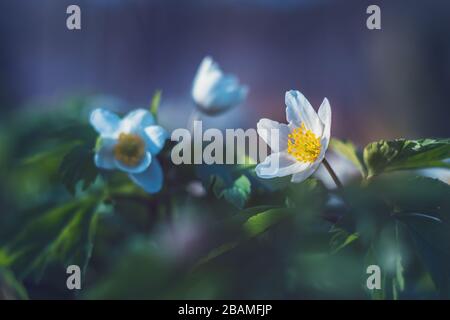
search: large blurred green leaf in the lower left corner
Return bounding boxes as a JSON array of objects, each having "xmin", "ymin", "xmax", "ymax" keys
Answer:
[{"xmin": 0, "ymin": 198, "xmax": 97, "ymax": 280}]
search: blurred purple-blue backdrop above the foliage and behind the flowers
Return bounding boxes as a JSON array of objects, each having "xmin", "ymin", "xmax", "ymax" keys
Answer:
[{"xmin": 0, "ymin": 0, "xmax": 450, "ymax": 144}]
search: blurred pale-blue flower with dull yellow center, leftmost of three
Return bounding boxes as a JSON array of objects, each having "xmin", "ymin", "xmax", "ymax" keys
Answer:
[{"xmin": 90, "ymin": 109, "xmax": 168, "ymax": 193}]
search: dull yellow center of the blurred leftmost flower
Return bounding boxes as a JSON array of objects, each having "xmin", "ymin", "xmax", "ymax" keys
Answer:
[{"xmin": 114, "ymin": 133, "xmax": 145, "ymax": 167}]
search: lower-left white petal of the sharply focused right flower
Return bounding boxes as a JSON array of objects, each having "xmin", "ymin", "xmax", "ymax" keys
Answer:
[{"xmin": 255, "ymin": 152, "xmax": 309, "ymax": 179}]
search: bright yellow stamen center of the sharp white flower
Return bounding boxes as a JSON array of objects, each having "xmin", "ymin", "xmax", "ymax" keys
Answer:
[{"xmin": 287, "ymin": 123, "xmax": 320, "ymax": 163}]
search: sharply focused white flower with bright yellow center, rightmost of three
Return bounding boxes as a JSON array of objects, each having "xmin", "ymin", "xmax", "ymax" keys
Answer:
[{"xmin": 256, "ymin": 90, "xmax": 331, "ymax": 182}]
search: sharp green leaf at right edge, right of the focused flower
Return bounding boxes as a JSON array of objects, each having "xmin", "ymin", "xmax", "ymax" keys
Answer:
[{"xmin": 364, "ymin": 139, "xmax": 450, "ymax": 177}]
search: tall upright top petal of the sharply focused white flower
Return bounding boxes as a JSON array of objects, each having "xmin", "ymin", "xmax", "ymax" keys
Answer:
[{"xmin": 285, "ymin": 90, "xmax": 323, "ymax": 137}]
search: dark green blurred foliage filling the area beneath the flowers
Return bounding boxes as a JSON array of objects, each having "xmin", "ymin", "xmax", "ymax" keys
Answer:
[{"xmin": 0, "ymin": 95, "xmax": 450, "ymax": 299}]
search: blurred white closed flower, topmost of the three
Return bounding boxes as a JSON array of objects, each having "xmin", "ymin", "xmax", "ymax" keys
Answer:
[{"xmin": 192, "ymin": 57, "xmax": 248, "ymax": 114}]
